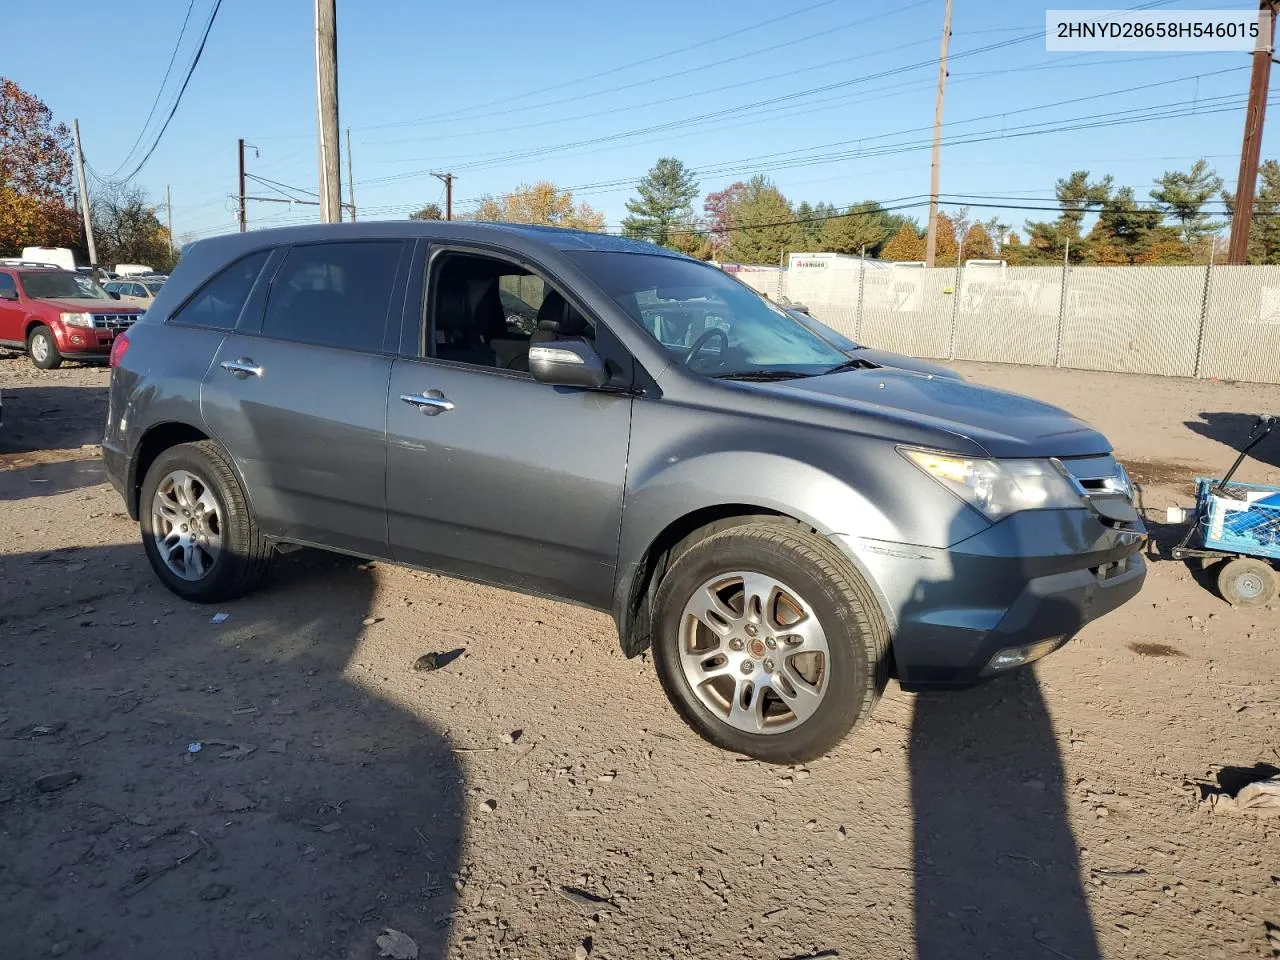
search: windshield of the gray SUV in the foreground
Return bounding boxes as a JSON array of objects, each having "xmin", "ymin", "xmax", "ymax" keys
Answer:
[{"xmin": 568, "ymin": 252, "xmax": 847, "ymax": 379}]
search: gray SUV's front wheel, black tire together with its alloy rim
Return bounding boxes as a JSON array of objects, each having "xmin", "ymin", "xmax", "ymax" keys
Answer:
[{"xmin": 653, "ymin": 520, "xmax": 890, "ymax": 763}]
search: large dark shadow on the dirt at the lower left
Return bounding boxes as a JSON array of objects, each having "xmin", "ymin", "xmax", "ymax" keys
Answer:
[{"xmin": 0, "ymin": 544, "xmax": 465, "ymax": 960}]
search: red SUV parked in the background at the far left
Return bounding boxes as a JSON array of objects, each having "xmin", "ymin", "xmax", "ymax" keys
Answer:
[{"xmin": 0, "ymin": 261, "xmax": 142, "ymax": 370}]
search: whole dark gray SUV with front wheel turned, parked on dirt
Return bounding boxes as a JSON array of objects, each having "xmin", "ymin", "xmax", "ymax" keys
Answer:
[{"xmin": 102, "ymin": 221, "xmax": 1146, "ymax": 762}]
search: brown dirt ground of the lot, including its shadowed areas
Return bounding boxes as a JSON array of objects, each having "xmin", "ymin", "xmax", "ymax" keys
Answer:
[{"xmin": 0, "ymin": 358, "xmax": 1280, "ymax": 960}]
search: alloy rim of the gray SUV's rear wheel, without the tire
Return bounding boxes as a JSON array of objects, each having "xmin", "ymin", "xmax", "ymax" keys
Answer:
[{"xmin": 151, "ymin": 470, "xmax": 223, "ymax": 582}]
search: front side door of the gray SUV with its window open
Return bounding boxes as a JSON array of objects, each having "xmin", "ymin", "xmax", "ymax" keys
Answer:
[{"xmin": 387, "ymin": 243, "xmax": 632, "ymax": 608}]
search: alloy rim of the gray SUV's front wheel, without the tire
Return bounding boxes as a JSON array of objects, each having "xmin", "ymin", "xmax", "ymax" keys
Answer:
[{"xmin": 678, "ymin": 571, "xmax": 831, "ymax": 735}]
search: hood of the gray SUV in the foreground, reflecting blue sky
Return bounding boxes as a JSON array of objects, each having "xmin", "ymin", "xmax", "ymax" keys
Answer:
[{"xmin": 742, "ymin": 367, "xmax": 1111, "ymax": 457}]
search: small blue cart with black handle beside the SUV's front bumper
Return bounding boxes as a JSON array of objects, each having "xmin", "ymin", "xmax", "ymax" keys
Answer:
[{"xmin": 1170, "ymin": 415, "xmax": 1280, "ymax": 607}]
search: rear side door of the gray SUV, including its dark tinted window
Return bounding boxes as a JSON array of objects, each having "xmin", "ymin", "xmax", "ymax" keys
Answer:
[{"xmin": 201, "ymin": 239, "xmax": 411, "ymax": 557}]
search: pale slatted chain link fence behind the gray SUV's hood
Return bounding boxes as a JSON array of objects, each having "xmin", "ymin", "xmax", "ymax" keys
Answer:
[{"xmin": 757, "ymin": 260, "xmax": 1280, "ymax": 383}]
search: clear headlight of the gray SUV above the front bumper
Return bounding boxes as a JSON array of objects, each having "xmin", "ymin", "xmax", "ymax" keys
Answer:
[{"xmin": 899, "ymin": 447, "xmax": 1084, "ymax": 520}]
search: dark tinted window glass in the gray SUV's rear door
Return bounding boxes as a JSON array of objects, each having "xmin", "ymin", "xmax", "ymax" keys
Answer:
[{"xmin": 262, "ymin": 241, "xmax": 402, "ymax": 352}]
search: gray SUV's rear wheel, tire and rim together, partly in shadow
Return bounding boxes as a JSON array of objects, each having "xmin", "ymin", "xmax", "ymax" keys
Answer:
[{"xmin": 138, "ymin": 440, "xmax": 275, "ymax": 603}]
